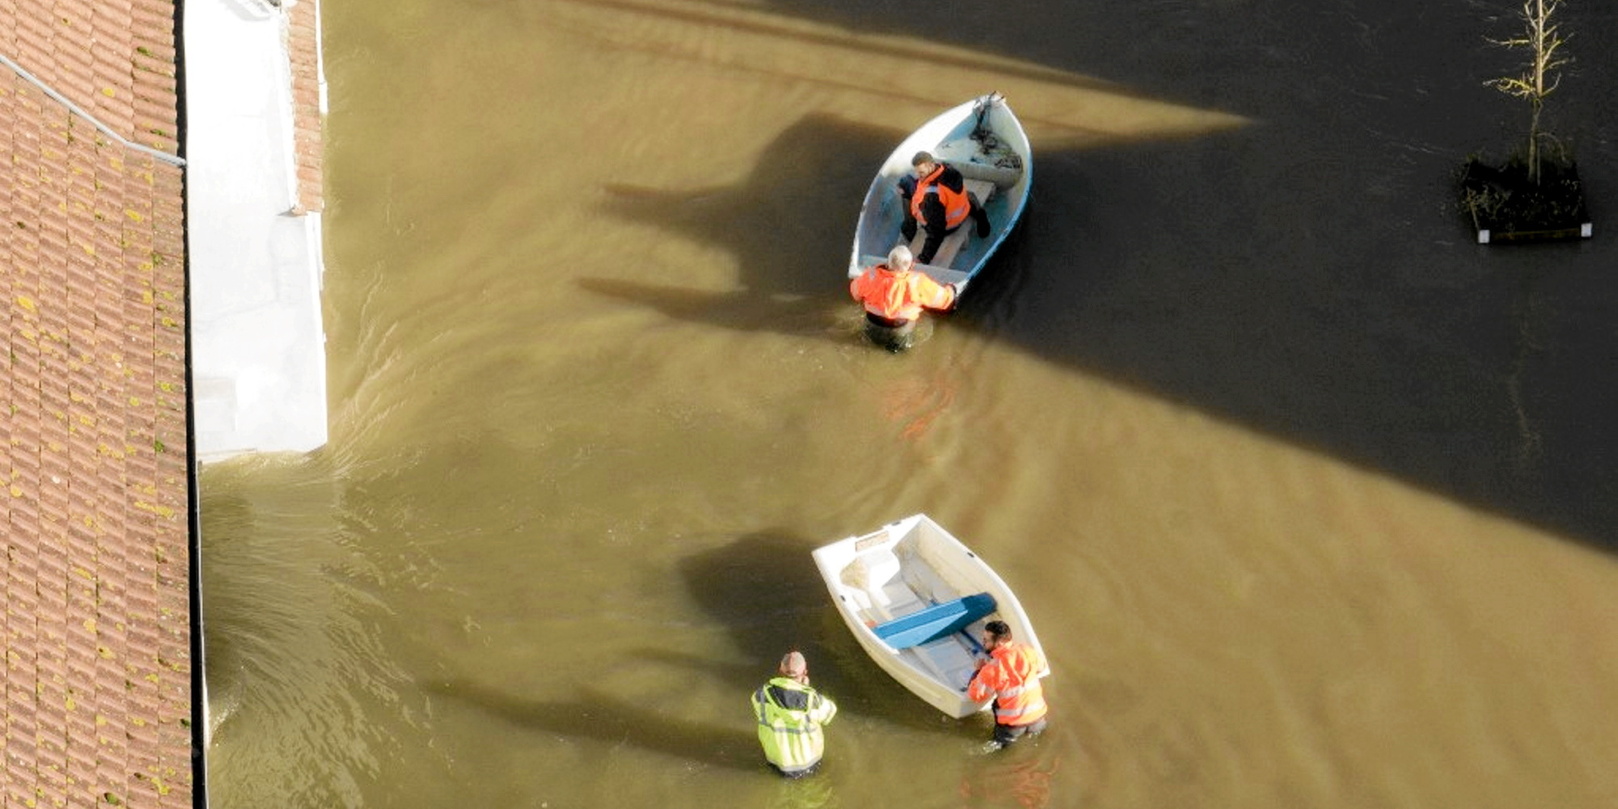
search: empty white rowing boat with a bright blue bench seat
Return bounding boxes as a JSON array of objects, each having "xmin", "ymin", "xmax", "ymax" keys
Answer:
[{"xmin": 814, "ymin": 515, "xmax": 1050, "ymax": 718}]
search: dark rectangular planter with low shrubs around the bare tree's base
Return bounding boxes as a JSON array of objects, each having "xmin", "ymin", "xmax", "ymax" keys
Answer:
[{"xmin": 1459, "ymin": 157, "xmax": 1592, "ymax": 244}]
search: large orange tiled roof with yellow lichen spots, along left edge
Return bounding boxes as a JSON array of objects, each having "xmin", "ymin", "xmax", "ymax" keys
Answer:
[{"xmin": 0, "ymin": 0, "xmax": 196, "ymax": 807}]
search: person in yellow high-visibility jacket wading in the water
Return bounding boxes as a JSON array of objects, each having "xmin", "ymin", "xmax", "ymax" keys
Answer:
[{"xmin": 752, "ymin": 650, "xmax": 837, "ymax": 778}]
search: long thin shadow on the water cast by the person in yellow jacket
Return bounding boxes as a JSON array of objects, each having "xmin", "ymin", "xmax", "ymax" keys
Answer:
[{"xmin": 424, "ymin": 681, "xmax": 759, "ymax": 772}]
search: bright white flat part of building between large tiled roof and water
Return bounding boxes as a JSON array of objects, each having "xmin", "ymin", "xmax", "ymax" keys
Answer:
[{"xmin": 183, "ymin": 0, "xmax": 327, "ymax": 461}]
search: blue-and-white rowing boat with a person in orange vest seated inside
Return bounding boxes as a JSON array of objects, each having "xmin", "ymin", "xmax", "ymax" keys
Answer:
[{"xmin": 848, "ymin": 92, "xmax": 1034, "ymax": 293}]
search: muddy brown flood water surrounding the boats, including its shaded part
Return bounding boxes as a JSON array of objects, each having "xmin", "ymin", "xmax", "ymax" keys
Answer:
[{"xmin": 201, "ymin": 0, "xmax": 1618, "ymax": 809}]
